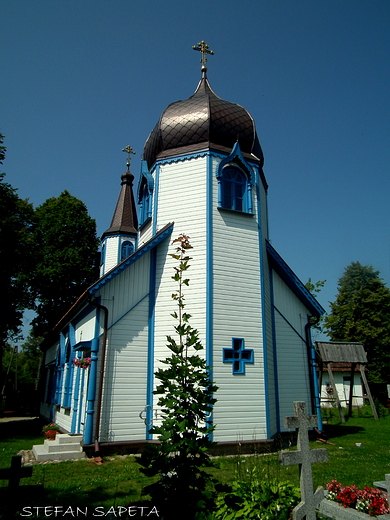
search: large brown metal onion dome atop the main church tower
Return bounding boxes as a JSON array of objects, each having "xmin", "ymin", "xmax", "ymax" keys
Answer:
[{"xmin": 144, "ymin": 73, "xmax": 264, "ymax": 168}]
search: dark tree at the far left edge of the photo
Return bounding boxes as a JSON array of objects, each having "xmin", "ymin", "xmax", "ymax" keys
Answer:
[{"xmin": 0, "ymin": 134, "xmax": 34, "ymax": 400}]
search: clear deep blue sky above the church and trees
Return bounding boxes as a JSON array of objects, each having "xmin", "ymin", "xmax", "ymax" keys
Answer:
[{"xmin": 0, "ymin": 0, "xmax": 390, "ymax": 334}]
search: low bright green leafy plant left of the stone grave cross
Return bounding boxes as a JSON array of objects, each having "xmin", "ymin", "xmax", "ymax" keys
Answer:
[{"xmin": 214, "ymin": 469, "xmax": 300, "ymax": 520}]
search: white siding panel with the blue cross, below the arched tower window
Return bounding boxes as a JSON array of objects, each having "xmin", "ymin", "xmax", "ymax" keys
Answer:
[{"xmin": 213, "ymin": 158, "xmax": 267, "ymax": 441}]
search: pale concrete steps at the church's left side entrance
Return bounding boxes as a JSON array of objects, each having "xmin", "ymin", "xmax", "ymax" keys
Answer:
[{"xmin": 33, "ymin": 433, "xmax": 85, "ymax": 462}]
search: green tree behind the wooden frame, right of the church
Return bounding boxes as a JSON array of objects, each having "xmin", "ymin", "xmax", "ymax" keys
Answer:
[{"xmin": 325, "ymin": 262, "xmax": 390, "ymax": 383}]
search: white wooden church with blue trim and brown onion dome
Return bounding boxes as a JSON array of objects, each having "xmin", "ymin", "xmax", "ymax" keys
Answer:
[{"xmin": 41, "ymin": 42, "xmax": 324, "ymax": 444}]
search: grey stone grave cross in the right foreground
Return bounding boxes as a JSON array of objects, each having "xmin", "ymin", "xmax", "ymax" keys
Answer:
[{"xmin": 280, "ymin": 401, "xmax": 328, "ymax": 520}]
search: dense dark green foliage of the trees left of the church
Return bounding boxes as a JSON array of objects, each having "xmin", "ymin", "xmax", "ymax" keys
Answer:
[{"xmin": 0, "ymin": 134, "xmax": 98, "ymax": 411}]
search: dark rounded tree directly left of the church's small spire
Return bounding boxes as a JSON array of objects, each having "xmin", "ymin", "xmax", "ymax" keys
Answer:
[{"xmin": 32, "ymin": 190, "xmax": 98, "ymax": 336}]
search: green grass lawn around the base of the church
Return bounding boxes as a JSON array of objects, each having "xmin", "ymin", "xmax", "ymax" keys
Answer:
[{"xmin": 0, "ymin": 415, "xmax": 390, "ymax": 518}]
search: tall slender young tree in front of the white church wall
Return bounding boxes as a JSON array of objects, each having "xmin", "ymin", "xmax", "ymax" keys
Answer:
[{"xmin": 139, "ymin": 235, "xmax": 217, "ymax": 519}]
